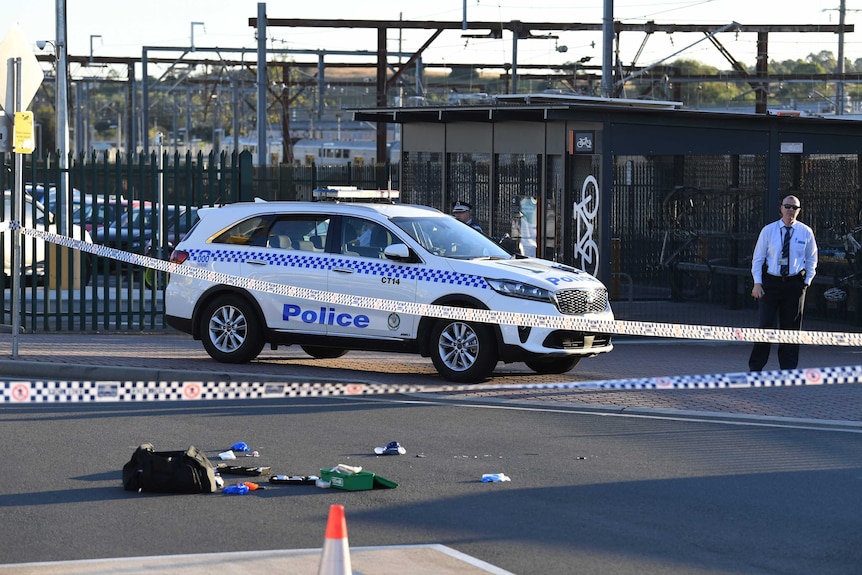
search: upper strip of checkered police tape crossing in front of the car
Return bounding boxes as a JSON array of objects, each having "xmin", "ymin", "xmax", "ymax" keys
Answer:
[{"xmin": 10, "ymin": 227, "xmax": 862, "ymax": 346}]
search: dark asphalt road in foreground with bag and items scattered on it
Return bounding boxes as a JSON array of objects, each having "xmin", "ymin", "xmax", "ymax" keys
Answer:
[{"xmin": 0, "ymin": 382, "xmax": 862, "ymax": 575}]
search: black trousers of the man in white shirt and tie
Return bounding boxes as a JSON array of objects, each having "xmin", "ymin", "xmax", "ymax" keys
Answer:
[{"xmin": 748, "ymin": 274, "xmax": 806, "ymax": 371}]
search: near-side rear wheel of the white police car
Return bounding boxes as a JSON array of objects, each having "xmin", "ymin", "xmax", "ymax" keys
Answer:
[{"xmin": 201, "ymin": 295, "xmax": 264, "ymax": 363}]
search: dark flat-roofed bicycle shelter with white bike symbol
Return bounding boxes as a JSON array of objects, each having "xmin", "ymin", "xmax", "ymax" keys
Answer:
[{"xmin": 354, "ymin": 94, "xmax": 862, "ymax": 325}]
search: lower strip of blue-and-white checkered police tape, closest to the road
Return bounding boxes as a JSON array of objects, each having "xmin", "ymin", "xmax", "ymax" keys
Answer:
[{"xmin": 0, "ymin": 365, "xmax": 862, "ymax": 403}]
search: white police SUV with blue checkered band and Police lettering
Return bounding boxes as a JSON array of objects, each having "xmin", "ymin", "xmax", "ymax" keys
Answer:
[{"xmin": 165, "ymin": 201, "xmax": 613, "ymax": 383}]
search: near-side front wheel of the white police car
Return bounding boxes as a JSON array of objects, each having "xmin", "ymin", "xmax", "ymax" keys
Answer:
[{"xmin": 431, "ymin": 320, "xmax": 498, "ymax": 383}]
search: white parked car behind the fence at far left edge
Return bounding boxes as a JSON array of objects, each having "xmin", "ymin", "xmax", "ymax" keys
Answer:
[{"xmin": 2, "ymin": 190, "xmax": 92, "ymax": 285}]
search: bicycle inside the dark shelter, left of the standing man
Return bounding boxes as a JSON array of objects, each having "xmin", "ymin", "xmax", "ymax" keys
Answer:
[{"xmin": 659, "ymin": 230, "xmax": 712, "ymax": 301}]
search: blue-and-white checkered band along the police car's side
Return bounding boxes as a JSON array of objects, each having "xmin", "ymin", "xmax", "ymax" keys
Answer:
[{"xmin": 189, "ymin": 248, "xmax": 488, "ymax": 289}]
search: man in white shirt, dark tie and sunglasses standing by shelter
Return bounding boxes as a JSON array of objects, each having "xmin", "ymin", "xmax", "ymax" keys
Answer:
[{"xmin": 748, "ymin": 196, "xmax": 817, "ymax": 371}]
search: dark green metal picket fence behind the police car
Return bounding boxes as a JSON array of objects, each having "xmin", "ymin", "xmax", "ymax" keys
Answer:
[{"xmin": 0, "ymin": 152, "xmax": 398, "ymax": 332}]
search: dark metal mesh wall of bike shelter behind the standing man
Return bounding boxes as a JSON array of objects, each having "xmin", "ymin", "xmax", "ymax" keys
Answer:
[{"xmin": 612, "ymin": 155, "xmax": 862, "ymax": 325}]
